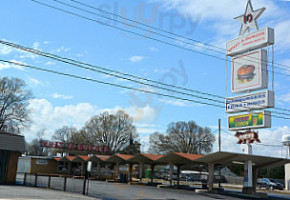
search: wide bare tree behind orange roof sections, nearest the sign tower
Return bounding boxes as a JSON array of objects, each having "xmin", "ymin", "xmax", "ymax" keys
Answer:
[{"xmin": 149, "ymin": 121, "xmax": 215, "ymax": 154}]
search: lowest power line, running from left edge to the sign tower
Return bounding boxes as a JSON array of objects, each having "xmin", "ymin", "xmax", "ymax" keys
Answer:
[{"xmin": 0, "ymin": 59, "xmax": 224, "ymax": 108}]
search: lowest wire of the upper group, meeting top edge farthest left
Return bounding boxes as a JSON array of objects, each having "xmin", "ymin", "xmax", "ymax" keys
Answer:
[{"xmin": 31, "ymin": 0, "xmax": 290, "ymax": 76}]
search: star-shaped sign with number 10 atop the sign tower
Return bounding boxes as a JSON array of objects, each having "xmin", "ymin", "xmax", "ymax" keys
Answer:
[{"xmin": 234, "ymin": 0, "xmax": 266, "ymax": 35}]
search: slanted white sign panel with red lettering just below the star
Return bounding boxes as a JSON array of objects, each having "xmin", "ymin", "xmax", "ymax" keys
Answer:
[{"xmin": 226, "ymin": 28, "xmax": 275, "ymax": 56}]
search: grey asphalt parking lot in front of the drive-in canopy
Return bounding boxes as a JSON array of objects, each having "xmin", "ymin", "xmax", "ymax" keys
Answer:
[{"xmin": 11, "ymin": 176, "xmax": 290, "ymax": 200}]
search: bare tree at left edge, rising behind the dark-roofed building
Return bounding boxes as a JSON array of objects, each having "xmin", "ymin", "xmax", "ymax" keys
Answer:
[{"xmin": 0, "ymin": 77, "xmax": 31, "ymax": 134}]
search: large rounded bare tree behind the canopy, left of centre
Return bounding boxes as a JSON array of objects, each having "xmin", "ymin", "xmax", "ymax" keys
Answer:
[{"xmin": 81, "ymin": 111, "xmax": 138, "ymax": 153}]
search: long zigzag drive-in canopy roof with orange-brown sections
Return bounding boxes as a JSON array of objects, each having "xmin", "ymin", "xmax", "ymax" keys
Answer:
[{"xmin": 55, "ymin": 152, "xmax": 290, "ymax": 169}]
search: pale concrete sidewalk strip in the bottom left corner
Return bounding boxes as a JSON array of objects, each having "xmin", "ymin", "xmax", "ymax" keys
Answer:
[{"xmin": 0, "ymin": 185, "xmax": 101, "ymax": 200}]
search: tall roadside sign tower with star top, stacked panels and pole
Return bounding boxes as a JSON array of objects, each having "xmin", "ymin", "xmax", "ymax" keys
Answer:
[{"xmin": 225, "ymin": 0, "xmax": 275, "ymax": 194}]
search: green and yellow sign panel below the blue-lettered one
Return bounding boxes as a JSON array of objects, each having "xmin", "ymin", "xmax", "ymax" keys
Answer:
[{"xmin": 228, "ymin": 111, "xmax": 271, "ymax": 131}]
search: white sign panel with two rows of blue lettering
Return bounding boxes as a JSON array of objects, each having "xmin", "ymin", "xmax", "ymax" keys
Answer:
[{"xmin": 226, "ymin": 90, "xmax": 275, "ymax": 113}]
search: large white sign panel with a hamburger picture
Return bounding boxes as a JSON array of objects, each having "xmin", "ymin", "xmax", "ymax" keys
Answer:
[{"xmin": 232, "ymin": 49, "xmax": 268, "ymax": 93}]
